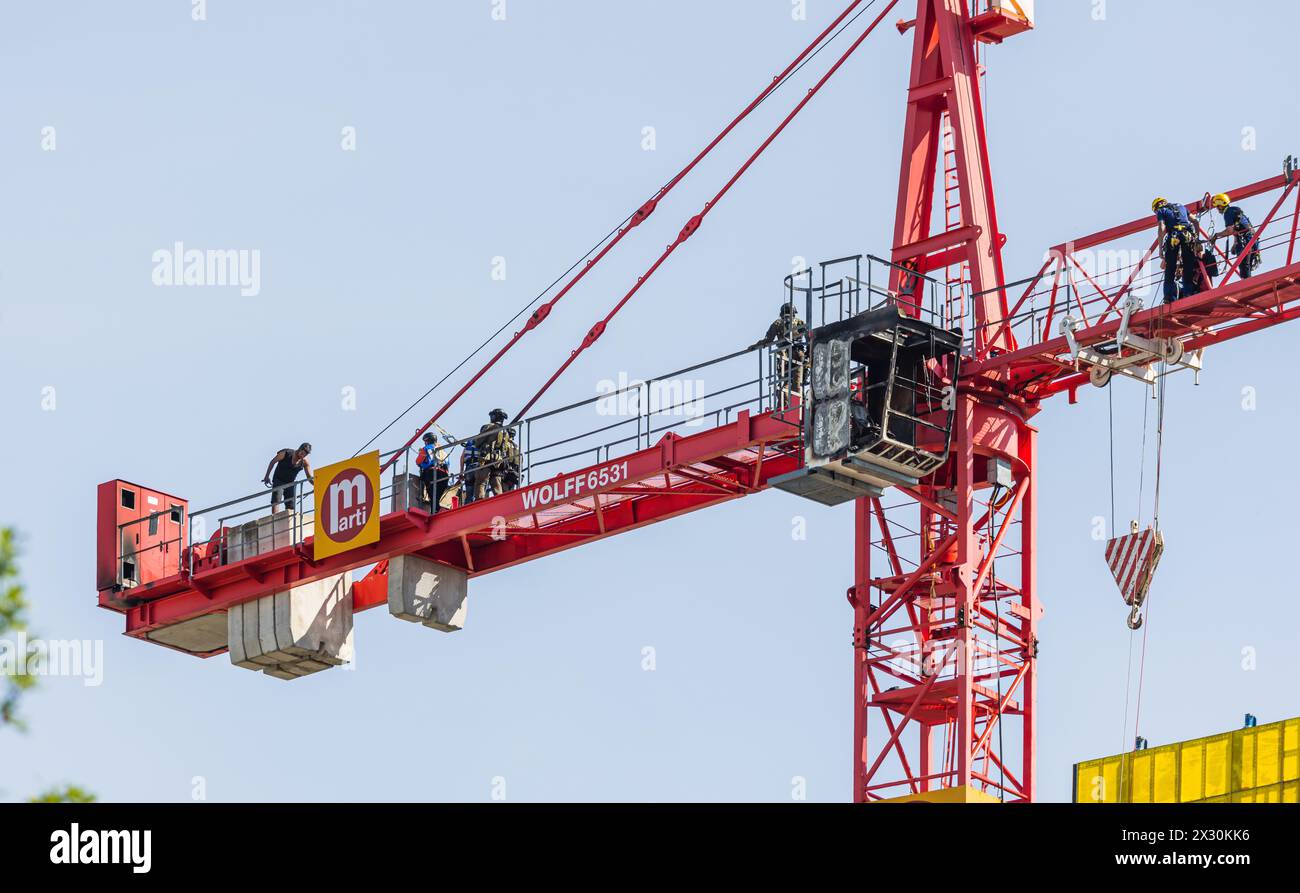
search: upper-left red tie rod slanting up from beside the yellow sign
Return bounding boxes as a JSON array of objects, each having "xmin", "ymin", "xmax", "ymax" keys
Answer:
[{"xmin": 371, "ymin": 0, "xmax": 893, "ymax": 469}]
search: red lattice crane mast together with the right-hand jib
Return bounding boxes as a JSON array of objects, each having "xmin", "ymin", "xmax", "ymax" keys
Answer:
[{"xmin": 849, "ymin": 0, "xmax": 1300, "ymax": 802}]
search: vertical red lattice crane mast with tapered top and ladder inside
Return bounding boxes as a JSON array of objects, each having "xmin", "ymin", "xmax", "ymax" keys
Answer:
[{"xmin": 849, "ymin": 0, "xmax": 1041, "ymax": 802}]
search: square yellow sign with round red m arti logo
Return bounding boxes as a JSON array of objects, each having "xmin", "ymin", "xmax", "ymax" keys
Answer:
[{"xmin": 312, "ymin": 451, "xmax": 380, "ymax": 560}]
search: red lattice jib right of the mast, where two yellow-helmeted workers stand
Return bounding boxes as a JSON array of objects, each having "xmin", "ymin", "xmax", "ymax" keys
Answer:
[{"xmin": 962, "ymin": 174, "xmax": 1300, "ymax": 403}]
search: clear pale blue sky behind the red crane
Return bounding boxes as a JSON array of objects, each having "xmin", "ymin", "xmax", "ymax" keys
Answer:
[{"xmin": 0, "ymin": 0, "xmax": 1300, "ymax": 801}]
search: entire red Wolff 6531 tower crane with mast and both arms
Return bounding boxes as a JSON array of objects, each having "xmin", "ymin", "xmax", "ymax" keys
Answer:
[{"xmin": 98, "ymin": 0, "xmax": 1300, "ymax": 802}]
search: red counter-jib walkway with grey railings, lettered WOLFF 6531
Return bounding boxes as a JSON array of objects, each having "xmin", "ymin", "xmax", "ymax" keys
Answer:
[{"xmin": 109, "ymin": 347, "xmax": 803, "ymax": 656}]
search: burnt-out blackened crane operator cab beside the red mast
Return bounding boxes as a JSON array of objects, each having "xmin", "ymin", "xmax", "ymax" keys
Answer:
[{"xmin": 772, "ymin": 305, "xmax": 962, "ymax": 506}]
